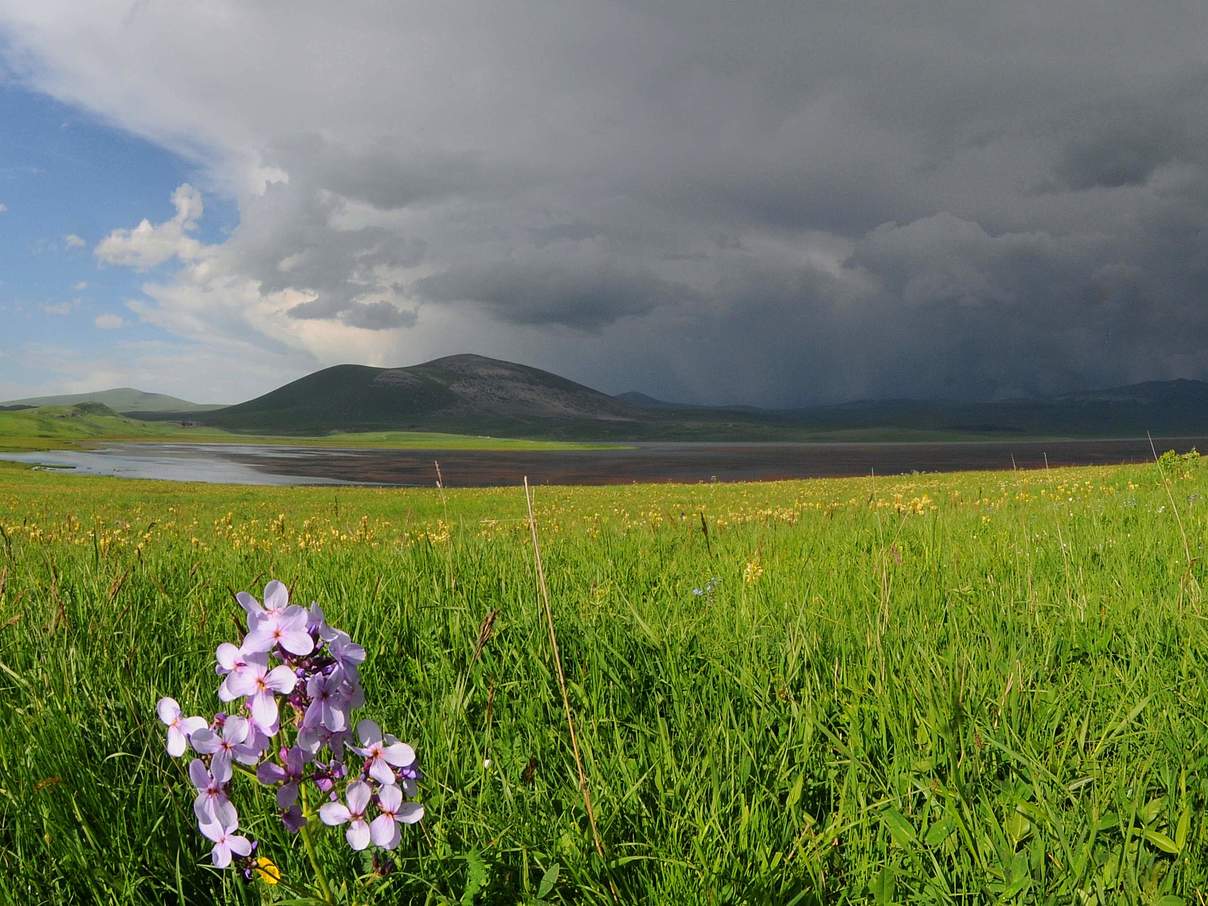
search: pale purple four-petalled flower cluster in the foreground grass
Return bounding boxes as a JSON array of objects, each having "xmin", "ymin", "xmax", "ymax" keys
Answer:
[{"xmin": 156, "ymin": 580, "xmax": 424, "ymax": 876}]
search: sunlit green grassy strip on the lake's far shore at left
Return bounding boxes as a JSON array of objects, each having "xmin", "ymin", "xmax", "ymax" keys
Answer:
[{"xmin": 0, "ymin": 405, "xmax": 616, "ymax": 451}]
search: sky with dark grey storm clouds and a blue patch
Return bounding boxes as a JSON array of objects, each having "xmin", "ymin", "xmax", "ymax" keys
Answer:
[{"xmin": 0, "ymin": 0, "xmax": 1208, "ymax": 407}]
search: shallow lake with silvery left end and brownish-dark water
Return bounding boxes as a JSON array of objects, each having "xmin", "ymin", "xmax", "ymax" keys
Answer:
[{"xmin": 0, "ymin": 437, "xmax": 1208, "ymax": 487}]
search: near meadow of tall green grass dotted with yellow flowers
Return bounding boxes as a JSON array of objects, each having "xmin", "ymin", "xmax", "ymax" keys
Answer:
[{"xmin": 0, "ymin": 458, "xmax": 1208, "ymax": 905}]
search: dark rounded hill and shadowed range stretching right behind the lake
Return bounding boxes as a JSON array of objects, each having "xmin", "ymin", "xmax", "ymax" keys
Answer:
[{"xmin": 181, "ymin": 355, "xmax": 1208, "ymax": 441}]
